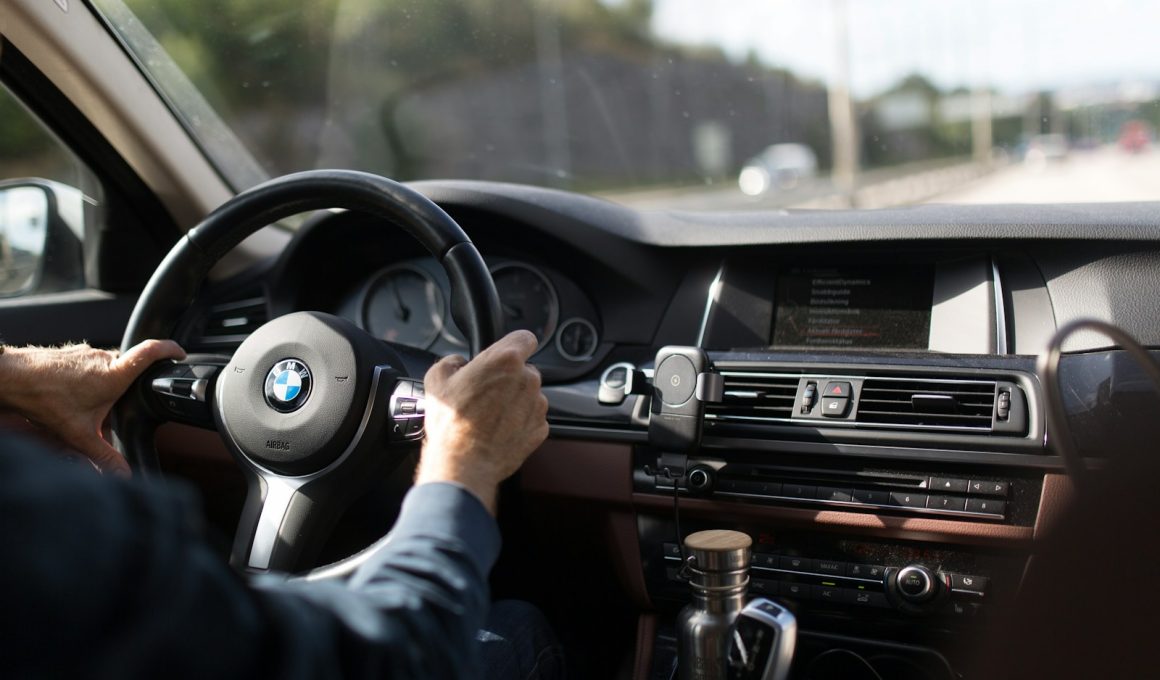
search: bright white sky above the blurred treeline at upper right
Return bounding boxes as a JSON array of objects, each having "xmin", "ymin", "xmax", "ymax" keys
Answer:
[{"xmin": 653, "ymin": 0, "xmax": 1160, "ymax": 96}]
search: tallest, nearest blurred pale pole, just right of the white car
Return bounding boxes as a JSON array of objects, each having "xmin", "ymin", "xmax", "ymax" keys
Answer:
[{"xmin": 828, "ymin": 0, "xmax": 858, "ymax": 205}]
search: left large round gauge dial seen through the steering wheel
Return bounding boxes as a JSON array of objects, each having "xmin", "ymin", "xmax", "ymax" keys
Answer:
[{"xmin": 362, "ymin": 265, "xmax": 443, "ymax": 349}]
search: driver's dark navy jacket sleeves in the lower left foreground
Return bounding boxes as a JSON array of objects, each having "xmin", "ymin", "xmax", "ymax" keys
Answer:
[{"xmin": 0, "ymin": 436, "xmax": 500, "ymax": 679}]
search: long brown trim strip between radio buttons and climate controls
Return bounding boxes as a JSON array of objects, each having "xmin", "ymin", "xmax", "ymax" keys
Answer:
[{"xmin": 632, "ymin": 493, "xmax": 1034, "ymax": 545}]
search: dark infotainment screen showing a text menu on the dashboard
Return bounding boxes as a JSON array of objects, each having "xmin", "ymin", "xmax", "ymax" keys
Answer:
[{"xmin": 771, "ymin": 266, "xmax": 934, "ymax": 349}]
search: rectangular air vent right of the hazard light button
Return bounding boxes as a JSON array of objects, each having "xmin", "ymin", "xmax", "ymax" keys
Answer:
[{"xmin": 856, "ymin": 378, "xmax": 996, "ymax": 432}]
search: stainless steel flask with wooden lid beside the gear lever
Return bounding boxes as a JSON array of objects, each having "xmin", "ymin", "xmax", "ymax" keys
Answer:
[{"xmin": 676, "ymin": 530, "xmax": 753, "ymax": 680}]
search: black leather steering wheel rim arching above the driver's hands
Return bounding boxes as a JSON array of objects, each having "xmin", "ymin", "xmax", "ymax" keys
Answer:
[{"xmin": 113, "ymin": 169, "xmax": 503, "ymax": 470}]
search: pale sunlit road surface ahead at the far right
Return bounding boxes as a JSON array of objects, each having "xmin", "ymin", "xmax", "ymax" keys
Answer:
[{"xmin": 928, "ymin": 147, "xmax": 1160, "ymax": 203}]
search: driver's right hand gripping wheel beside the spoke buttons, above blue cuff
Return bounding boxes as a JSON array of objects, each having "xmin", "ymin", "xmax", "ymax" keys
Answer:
[{"xmin": 415, "ymin": 331, "xmax": 548, "ymax": 514}]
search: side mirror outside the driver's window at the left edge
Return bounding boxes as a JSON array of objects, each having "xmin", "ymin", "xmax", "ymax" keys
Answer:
[{"xmin": 0, "ymin": 180, "xmax": 85, "ymax": 297}]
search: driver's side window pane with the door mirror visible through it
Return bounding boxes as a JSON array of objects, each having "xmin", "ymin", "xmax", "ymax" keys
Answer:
[{"xmin": 0, "ymin": 81, "xmax": 93, "ymax": 293}]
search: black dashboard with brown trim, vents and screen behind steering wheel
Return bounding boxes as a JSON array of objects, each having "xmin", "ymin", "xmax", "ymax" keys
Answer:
[{"xmin": 183, "ymin": 182, "xmax": 1160, "ymax": 678}]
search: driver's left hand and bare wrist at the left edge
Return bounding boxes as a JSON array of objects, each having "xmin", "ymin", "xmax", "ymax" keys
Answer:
[{"xmin": 0, "ymin": 340, "xmax": 186, "ymax": 477}]
